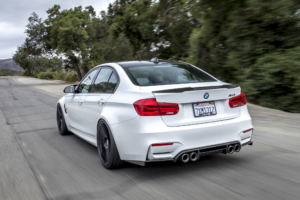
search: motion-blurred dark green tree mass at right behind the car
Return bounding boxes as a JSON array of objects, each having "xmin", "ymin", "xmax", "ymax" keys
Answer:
[{"xmin": 187, "ymin": 0, "xmax": 300, "ymax": 111}]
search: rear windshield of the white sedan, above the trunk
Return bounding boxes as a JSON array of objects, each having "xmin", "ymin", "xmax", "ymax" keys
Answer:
[{"xmin": 120, "ymin": 64, "xmax": 216, "ymax": 86}]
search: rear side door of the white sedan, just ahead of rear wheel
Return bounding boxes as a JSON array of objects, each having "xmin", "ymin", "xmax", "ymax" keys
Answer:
[{"xmin": 83, "ymin": 67, "xmax": 118, "ymax": 138}]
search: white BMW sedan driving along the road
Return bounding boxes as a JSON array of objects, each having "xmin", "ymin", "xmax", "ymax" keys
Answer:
[{"xmin": 57, "ymin": 58, "xmax": 253, "ymax": 168}]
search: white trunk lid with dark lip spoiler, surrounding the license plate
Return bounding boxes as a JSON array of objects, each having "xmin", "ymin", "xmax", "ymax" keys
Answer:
[{"xmin": 140, "ymin": 82, "xmax": 241, "ymax": 126}]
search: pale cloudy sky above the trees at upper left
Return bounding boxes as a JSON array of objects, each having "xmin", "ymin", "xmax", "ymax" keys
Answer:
[{"xmin": 0, "ymin": 0, "xmax": 113, "ymax": 59}]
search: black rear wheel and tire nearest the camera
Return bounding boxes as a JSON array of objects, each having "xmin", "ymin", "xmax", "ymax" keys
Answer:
[{"xmin": 97, "ymin": 120, "xmax": 123, "ymax": 169}]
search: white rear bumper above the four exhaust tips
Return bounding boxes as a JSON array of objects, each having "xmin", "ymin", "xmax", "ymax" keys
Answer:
[{"xmin": 111, "ymin": 106, "xmax": 253, "ymax": 162}]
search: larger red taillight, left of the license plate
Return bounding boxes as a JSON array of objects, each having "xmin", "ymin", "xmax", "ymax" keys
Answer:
[{"xmin": 133, "ymin": 98, "xmax": 179, "ymax": 116}]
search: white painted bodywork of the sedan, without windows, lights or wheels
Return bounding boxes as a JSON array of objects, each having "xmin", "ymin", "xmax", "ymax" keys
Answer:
[{"xmin": 59, "ymin": 63, "xmax": 253, "ymax": 161}]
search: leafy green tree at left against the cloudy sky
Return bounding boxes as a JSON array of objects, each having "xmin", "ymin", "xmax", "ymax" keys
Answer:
[{"xmin": 16, "ymin": 5, "xmax": 133, "ymax": 80}]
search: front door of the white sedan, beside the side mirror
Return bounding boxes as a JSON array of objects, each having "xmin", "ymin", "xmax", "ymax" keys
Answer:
[{"xmin": 66, "ymin": 68, "xmax": 99, "ymax": 134}]
